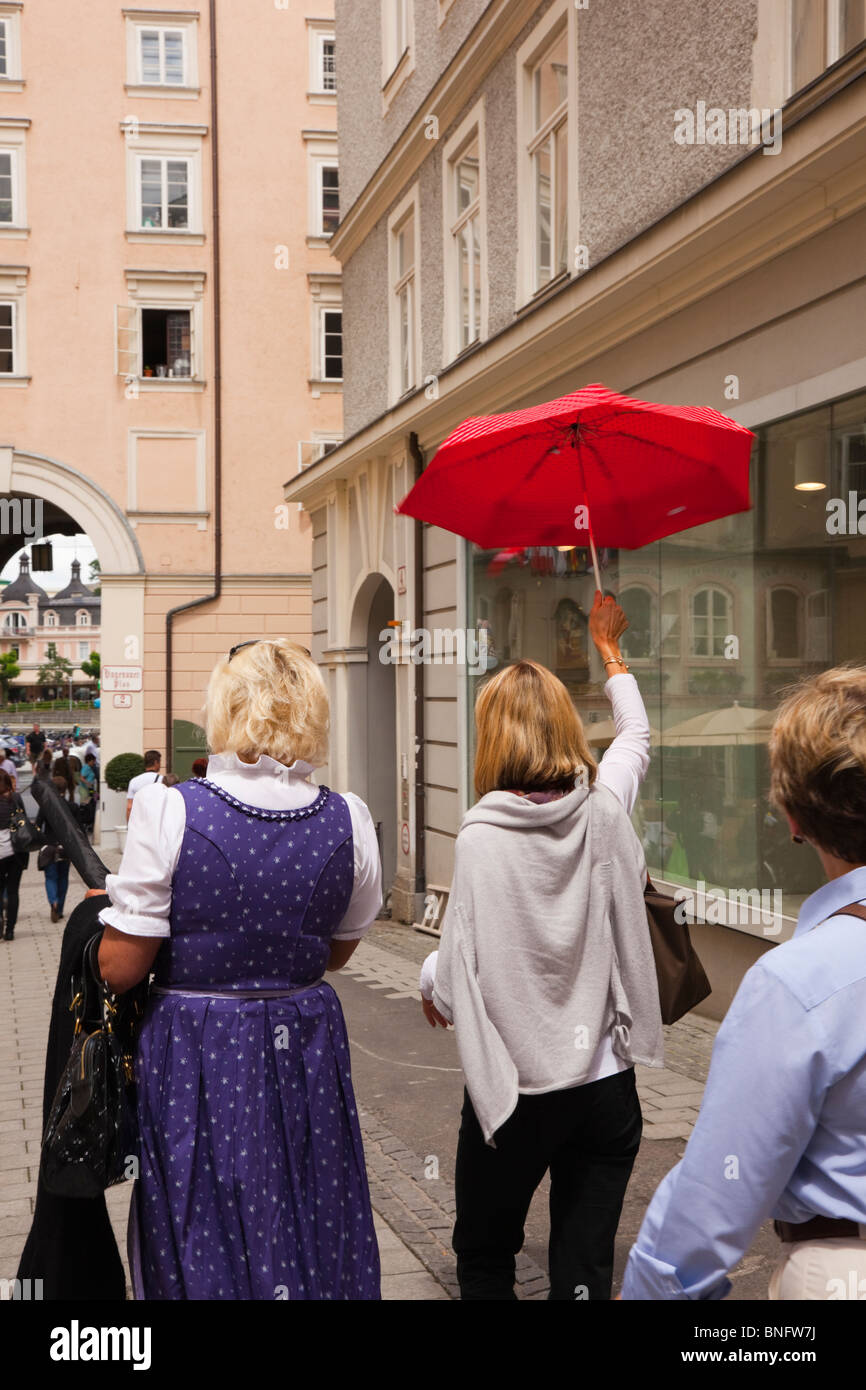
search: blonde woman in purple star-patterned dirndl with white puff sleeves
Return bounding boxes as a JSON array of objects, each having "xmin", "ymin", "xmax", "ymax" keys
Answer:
[{"xmin": 99, "ymin": 639, "xmax": 381, "ymax": 1300}]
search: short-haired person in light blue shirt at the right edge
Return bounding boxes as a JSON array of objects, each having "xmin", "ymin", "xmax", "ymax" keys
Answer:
[{"xmin": 623, "ymin": 666, "xmax": 866, "ymax": 1300}]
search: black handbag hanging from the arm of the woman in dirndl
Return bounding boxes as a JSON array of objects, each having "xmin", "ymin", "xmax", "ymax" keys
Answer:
[{"xmin": 40, "ymin": 931, "xmax": 147, "ymax": 1197}]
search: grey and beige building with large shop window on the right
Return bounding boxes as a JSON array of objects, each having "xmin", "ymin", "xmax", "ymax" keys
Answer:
[{"xmin": 286, "ymin": 0, "xmax": 866, "ymax": 1016}]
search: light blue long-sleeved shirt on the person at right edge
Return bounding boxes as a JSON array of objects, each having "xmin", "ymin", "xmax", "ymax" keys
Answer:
[{"xmin": 623, "ymin": 867, "xmax": 866, "ymax": 1298}]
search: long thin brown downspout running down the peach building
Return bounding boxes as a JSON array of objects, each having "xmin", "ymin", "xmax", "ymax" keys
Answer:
[{"xmin": 165, "ymin": 0, "xmax": 222, "ymax": 771}]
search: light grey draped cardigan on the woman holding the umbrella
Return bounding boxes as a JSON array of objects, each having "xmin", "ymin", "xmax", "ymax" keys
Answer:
[{"xmin": 434, "ymin": 783, "xmax": 664, "ymax": 1147}]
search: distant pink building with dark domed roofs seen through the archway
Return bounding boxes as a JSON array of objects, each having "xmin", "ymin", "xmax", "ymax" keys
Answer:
[{"xmin": 0, "ymin": 550, "xmax": 101, "ymax": 701}]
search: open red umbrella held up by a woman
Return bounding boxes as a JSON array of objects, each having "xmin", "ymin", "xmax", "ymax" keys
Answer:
[{"xmin": 396, "ymin": 385, "xmax": 753, "ymax": 588}]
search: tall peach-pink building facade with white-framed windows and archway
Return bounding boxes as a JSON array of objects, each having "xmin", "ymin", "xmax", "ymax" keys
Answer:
[{"xmin": 0, "ymin": 0, "xmax": 342, "ymax": 771}]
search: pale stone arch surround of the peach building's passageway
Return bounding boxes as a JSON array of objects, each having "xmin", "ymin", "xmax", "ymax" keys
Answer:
[{"xmin": 0, "ymin": 446, "xmax": 145, "ymax": 789}]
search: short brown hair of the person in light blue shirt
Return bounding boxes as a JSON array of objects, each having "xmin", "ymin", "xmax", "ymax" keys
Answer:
[{"xmin": 770, "ymin": 666, "xmax": 866, "ymax": 865}]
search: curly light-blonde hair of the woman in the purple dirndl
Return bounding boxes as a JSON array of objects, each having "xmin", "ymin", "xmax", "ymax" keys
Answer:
[{"xmin": 204, "ymin": 637, "xmax": 328, "ymax": 767}]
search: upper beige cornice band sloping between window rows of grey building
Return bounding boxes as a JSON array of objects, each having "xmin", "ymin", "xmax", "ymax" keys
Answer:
[{"xmin": 331, "ymin": 0, "xmax": 538, "ymax": 264}]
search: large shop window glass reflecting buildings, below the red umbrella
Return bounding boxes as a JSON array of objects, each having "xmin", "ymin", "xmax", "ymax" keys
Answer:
[{"xmin": 467, "ymin": 393, "xmax": 866, "ymax": 916}]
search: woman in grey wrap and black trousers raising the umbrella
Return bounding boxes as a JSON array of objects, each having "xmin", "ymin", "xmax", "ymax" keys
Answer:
[{"xmin": 421, "ymin": 592, "xmax": 663, "ymax": 1301}]
